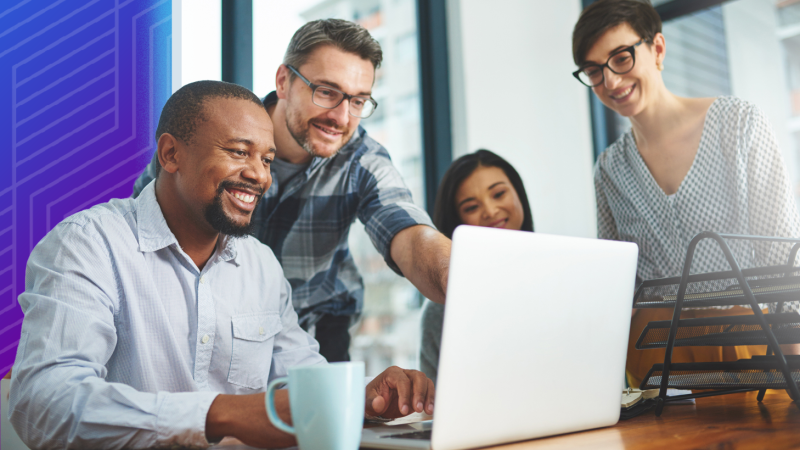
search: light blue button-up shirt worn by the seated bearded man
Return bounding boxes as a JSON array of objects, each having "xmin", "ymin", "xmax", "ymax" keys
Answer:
[{"xmin": 10, "ymin": 183, "xmax": 325, "ymax": 449}]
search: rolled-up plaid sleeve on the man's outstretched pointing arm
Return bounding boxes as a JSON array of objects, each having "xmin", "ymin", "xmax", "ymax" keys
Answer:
[{"xmin": 353, "ymin": 148, "xmax": 435, "ymax": 275}]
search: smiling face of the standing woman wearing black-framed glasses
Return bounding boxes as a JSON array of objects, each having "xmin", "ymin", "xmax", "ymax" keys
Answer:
[{"xmin": 586, "ymin": 23, "xmax": 666, "ymax": 117}]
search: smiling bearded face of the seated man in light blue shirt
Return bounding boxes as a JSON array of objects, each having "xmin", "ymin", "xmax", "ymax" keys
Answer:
[{"xmin": 170, "ymin": 98, "xmax": 275, "ymax": 236}]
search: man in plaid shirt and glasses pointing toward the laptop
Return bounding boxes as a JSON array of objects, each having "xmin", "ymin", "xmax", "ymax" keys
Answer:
[{"xmin": 134, "ymin": 19, "xmax": 450, "ymax": 362}]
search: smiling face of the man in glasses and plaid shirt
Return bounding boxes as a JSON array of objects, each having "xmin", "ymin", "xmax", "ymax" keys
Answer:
[{"xmin": 277, "ymin": 45, "xmax": 375, "ymax": 158}]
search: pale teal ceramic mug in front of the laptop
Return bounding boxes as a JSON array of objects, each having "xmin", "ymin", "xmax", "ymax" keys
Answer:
[{"xmin": 266, "ymin": 362, "xmax": 366, "ymax": 450}]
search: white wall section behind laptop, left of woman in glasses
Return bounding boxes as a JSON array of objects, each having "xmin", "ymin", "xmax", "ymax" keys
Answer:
[{"xmin": 447, "ymin": 0, "xmax": 597, "ymax": 237}]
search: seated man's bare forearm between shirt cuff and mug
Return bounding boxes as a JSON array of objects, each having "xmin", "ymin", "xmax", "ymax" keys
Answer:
[{"xmin": 206, "ymin": 389, "xmax": 297, "ymax": 448}]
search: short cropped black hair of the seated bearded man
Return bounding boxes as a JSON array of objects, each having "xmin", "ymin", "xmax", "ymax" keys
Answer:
[{"xmin": 156, "ymin": 80, "xmax": 264, "ymax": 175}]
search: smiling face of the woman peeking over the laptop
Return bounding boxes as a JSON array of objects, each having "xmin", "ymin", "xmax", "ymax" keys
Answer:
[{"xmin": 455, "ymin": 166, "xmax": 524, "ymax": 230}]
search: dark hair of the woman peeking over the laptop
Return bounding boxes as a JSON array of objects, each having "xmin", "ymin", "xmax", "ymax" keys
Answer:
[{"xmin": 433, "ymin": 149, "xmax": 533, "ymax": 239}]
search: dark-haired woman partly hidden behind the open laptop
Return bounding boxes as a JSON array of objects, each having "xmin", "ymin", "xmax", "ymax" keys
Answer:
[{"xmin": 420, "ymin": 150, "xmax": 533, "ymax": 383}]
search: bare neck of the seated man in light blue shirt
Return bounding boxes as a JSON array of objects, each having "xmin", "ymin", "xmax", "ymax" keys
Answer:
[{"xmin": 156, "ymin": 177, "xmax": 219, "ymax": 270}]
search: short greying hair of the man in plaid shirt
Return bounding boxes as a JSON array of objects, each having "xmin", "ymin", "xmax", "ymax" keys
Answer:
[{"xmin": 283, "ymin": 19, "xmax": 383, "ymax": 80}]
